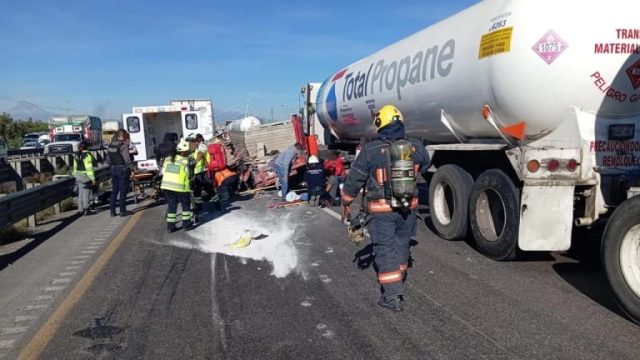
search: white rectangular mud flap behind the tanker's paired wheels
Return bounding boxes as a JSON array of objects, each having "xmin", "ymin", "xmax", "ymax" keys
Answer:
[{"xmin": 518, "ymin": 185, "xmax": 574, "ymax": 251}]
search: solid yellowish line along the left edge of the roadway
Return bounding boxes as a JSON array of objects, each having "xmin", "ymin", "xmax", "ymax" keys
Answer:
[{"xmin": 18, "ymin": 211, "xmax": 143, "ymax": 359}]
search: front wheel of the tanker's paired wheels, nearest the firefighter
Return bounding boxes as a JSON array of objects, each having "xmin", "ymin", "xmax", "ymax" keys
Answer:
[{"xmin": 429, "ymin": 165, "xmax": 473, "ymax": 240}]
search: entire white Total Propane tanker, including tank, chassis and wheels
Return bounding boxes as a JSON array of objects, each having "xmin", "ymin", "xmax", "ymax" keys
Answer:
[{"xmin": 315, "ymin": 0, "xmax": 640, "ymax": 323}]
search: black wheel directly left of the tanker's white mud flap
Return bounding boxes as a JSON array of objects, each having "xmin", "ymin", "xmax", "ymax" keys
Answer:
[{"xmin": 469, "ymin": 169, "xmax": 520, "ymax": 261}]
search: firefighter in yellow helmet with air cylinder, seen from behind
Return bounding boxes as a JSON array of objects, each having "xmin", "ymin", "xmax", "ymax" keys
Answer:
[{"xmin": 342, "ymin": 105, "xmax": 430, "ymax": 311}]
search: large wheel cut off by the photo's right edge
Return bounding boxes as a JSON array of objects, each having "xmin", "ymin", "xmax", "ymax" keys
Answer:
[{"xmin": 601, "ymin": 197, "xmax": 640, "ymax": 325}]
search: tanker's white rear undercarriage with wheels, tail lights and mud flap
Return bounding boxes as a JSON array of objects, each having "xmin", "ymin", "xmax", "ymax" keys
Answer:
[{"xmin": 427, "ymin": 108, "xmax": 640, "ymax": 324}]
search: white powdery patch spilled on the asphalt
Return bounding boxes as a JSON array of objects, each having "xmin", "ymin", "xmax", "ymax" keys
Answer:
[{"xmin": 169, "ymin": 211, "xmax": 302, "ymax": 278}]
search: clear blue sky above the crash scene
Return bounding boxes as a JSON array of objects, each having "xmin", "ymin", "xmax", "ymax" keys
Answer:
[{"xmin": 0, "ymin": 0, "xmax": 477, "ymax": 119}]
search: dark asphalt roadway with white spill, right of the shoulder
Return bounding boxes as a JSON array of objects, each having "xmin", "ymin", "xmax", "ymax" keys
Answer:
[{"xmin": 2, "ymin": 195, "xmax": 640, "ymax": 359}]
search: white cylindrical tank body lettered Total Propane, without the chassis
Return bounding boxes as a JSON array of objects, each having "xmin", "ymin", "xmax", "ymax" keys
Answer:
[{"xmin": 316, "ymin": 0, "xmax": 640, "ymax": 142}]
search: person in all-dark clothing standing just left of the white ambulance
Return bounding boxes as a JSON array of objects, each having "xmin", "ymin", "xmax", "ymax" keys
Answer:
[{"xmin": 107, "ymin": 129, "xmax": 132, "ymax": 217}]
